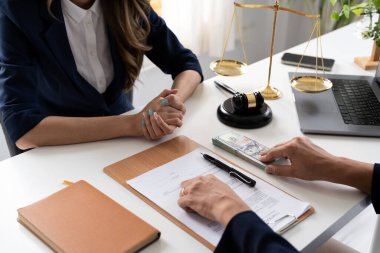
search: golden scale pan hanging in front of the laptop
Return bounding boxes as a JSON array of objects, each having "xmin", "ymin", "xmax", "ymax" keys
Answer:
[{"xmin": 290, "ymin": 76, "xmax": 332, "ymax": 93}]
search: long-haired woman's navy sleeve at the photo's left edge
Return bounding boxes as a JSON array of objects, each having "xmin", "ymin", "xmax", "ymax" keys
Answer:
[{"xmin": 0, "ymin": 9, "xmax": 45, "ymax": 142}]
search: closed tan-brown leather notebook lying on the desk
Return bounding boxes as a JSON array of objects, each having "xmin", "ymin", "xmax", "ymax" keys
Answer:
[{"xmin": 18, "ymin": 181, "xmax": 160, "ymax": 253}]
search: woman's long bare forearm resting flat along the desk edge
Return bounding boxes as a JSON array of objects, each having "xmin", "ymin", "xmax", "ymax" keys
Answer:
[{"xmin": 16, "ymin": 114, "xmax": 142, "ymax": 150}]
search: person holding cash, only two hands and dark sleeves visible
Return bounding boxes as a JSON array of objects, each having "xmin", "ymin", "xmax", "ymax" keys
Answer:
[{"xmin": 178, "ymin": 137, "xmax": 380, "ymax": 253}]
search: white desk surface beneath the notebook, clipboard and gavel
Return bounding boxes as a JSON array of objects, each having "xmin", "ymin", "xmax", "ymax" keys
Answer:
[{"xmin": 0, "ymin": 22, "xmax": 380, "ymax": 253}]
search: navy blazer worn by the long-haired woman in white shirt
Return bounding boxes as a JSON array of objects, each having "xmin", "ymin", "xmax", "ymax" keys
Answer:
[{"xmin": 0, "ymin": 0, "xmax": 202, "ymax": 142}]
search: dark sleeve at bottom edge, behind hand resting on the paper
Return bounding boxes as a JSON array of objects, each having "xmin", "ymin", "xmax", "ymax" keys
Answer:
[{"xmin": 215, "ymin": 211, "xmax": 298, "ymax": 253}]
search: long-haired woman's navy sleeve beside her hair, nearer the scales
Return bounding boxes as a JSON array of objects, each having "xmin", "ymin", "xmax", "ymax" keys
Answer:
[{"xmin": 146, "ymin": 9, "xmax": 203, "ymax": 81}]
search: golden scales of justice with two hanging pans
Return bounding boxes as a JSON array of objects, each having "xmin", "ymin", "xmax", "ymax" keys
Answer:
[{"xmin": 210, "ymin": 0, "xmax": 332, "ymax": 100}]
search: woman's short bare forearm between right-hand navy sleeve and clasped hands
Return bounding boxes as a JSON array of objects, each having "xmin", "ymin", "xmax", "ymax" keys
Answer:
[{"xmin": 172, "ymin": 70, "xmax": 201, "ymax": 102}]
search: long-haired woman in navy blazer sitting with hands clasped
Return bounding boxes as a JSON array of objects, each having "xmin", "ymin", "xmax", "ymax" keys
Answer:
[{"xmin": 0, "ymin": 0, "xmax": 202, "ymax": 149}]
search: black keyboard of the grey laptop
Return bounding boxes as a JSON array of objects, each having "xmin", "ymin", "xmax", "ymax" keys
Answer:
[{"xmin": 330, "ymin": 79, "xmax": 380, "ymax": 126}]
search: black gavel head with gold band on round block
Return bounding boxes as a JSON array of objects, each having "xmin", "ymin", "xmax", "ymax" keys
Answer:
[{"xmin": 232, "ymin": 92, "xmax": 264, "ymax": 112}]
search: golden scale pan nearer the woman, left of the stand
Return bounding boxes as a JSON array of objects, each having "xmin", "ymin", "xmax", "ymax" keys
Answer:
[{"xmin": 210, "ymin": 60, "xmax": 248, "ymax": 76}]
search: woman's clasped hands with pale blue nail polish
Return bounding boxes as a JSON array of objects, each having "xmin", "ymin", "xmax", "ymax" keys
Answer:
[{"xmin": 141, "ymin": 89, "xmax": 186, "ymax": 140}]
